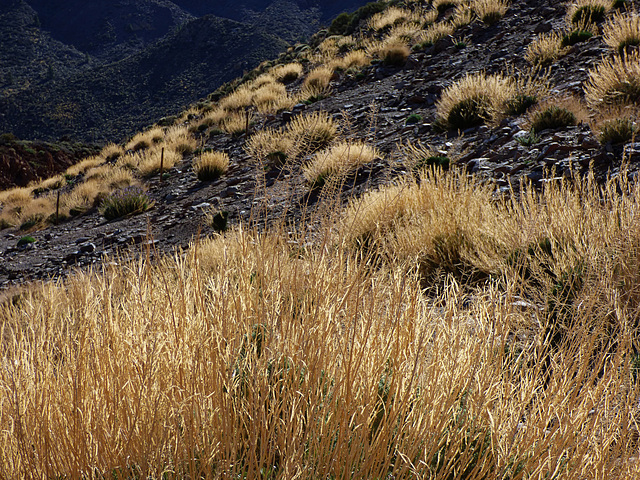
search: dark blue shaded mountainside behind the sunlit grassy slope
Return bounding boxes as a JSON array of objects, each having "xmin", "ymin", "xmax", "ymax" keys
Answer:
[{"xmin": 0, "ymin": 0, "xmax": 366, "ymax": 143}]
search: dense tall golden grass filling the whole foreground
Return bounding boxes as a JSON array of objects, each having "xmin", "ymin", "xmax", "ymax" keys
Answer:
[{"xmin": 0, "ymin": 168, "xmax": 640, "ymax": 480}]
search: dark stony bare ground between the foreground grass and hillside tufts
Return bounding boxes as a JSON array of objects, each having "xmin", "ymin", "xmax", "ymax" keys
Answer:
[{"xmin": 0, "ymin": 0, "xmax": 640, "ymax": 289}]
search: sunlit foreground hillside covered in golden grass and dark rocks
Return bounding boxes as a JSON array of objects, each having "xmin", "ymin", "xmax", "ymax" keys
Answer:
[{"xmin": 5, "ymin": 0, "xmax": 640, "ymax": 480}]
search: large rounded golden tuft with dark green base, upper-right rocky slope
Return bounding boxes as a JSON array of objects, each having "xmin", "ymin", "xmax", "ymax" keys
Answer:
[{"xmin": 436, "ymin": 72, "xmax": 516, "ymax": 129}]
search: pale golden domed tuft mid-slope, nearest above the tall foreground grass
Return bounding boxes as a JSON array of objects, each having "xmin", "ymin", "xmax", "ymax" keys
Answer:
[{"xmin": 302, "ymin": 141, "xmax": 380, "ymax": 186}]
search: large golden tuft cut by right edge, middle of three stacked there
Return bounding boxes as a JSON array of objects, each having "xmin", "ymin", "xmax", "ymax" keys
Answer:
[{"xmin": 584, "ymin": 51, "xmax": 640, "ymax": 108}]
